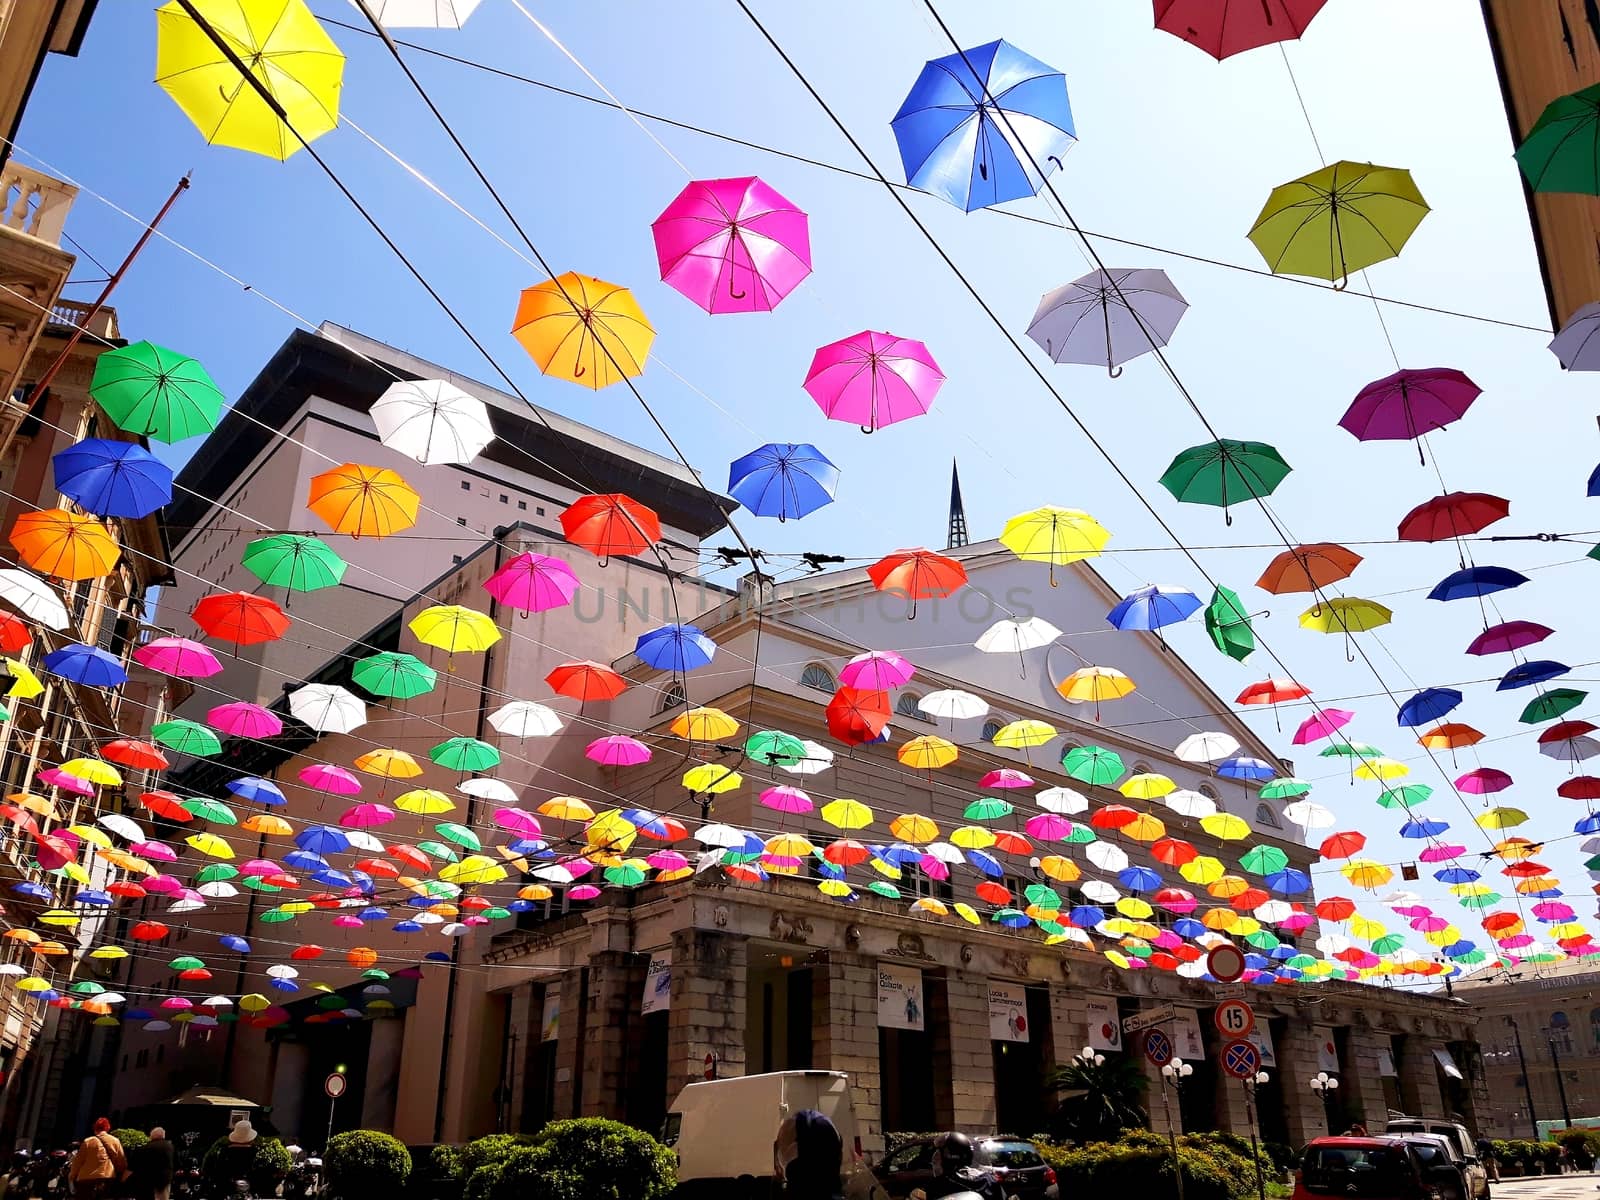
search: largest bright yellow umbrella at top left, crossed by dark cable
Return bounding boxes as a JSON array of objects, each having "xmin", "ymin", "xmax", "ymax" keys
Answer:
[{"xmin": 155, "ymin": 0, "xmax": 344, "ymax": 160}]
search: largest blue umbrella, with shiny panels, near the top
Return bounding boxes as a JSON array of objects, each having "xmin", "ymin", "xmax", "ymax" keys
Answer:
[{"xmin": 891, "ymin": 42, "xmax": 1077, "ymax": 213}]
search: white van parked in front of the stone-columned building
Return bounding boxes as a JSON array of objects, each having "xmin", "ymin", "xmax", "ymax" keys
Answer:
[{"xmin": 661, "ymin": 1070, "xmax": 886, "ymax": 1200}]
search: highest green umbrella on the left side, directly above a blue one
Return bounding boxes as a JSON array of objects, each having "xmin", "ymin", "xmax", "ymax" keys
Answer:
[{"xmin": 90, "ymin": 342, "xmax": 226, "ymax": 442}]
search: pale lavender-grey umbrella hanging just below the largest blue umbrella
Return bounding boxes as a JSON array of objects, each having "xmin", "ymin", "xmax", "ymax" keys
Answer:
[{"xmin": 1027, "ymin": 269, "xmax": 1189, "ymax": 378}]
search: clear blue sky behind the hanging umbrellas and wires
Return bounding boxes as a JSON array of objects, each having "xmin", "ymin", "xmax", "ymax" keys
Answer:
[{"xmin": 19, "ymin": 0, "xmax": 1600, "ymax": 966}]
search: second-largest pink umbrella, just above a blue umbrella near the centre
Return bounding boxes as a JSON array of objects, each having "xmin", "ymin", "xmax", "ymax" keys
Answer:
[{"xmin": 805, "ymin": 331, "xmax": 944, "ymax": 434}]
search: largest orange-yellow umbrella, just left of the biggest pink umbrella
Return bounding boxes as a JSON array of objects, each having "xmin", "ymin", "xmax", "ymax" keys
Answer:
[{"xmin": 510, "ymin": 270, "xmax": 656, "ymax": 390}]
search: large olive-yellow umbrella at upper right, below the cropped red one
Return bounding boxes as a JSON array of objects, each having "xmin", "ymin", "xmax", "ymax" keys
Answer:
[{"xmin": 1250, "ymin": 162, "xmax": 1427, "ymax": 286}]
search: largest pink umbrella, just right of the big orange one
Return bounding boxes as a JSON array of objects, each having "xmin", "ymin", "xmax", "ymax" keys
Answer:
[{"xmin": 650, "ymin": 176, "xmax": 811, "ymax": 314}]
